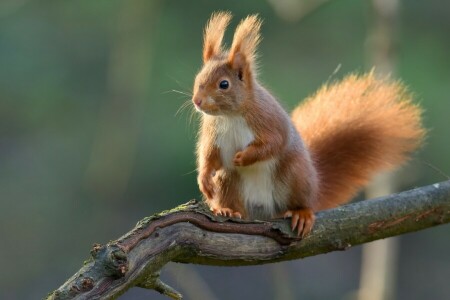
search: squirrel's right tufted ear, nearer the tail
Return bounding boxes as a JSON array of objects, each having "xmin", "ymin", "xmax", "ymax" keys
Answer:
[{"xmin": 228, "ymin": 15, "xmax": 262, "ymax": 79}]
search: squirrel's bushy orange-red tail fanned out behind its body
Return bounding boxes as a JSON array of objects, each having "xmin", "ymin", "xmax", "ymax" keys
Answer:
[{"xmin": 292, "ymin": 73, "xmax": 425, "ymax": 210}]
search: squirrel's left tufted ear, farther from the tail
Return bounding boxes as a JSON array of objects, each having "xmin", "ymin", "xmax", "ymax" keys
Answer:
[{"xmin": 203, "ymin": 12, "xmax": 231, "ymax": 63}]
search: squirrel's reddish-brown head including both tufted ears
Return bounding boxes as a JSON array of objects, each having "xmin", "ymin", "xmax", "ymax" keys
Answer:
[{"xmin": 192, "ymin": 12, "xmax": 261, "ymax": 115}]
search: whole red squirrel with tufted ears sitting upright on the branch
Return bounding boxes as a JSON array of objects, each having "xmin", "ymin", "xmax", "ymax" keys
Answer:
[{"xmin": 192, "ymin": 12, "xmax": 425, "ymax": 237}]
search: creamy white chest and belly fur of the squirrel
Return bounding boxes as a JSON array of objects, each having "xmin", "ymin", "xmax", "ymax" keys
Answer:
[{"xmin": 216, "ymin": 116, "xmax": 276, "ymax": 218}]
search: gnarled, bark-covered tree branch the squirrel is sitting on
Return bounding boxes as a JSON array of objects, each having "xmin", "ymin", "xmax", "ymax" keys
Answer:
[{"xmin": 47, "ymin": 181, "xmax": 450, "ymax": 299}]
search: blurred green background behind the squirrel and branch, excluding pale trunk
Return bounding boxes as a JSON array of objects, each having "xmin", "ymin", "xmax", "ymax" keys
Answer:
[{"xmin": 0, "ymin": 0, "xmax": 450, "ymax": 299}]
